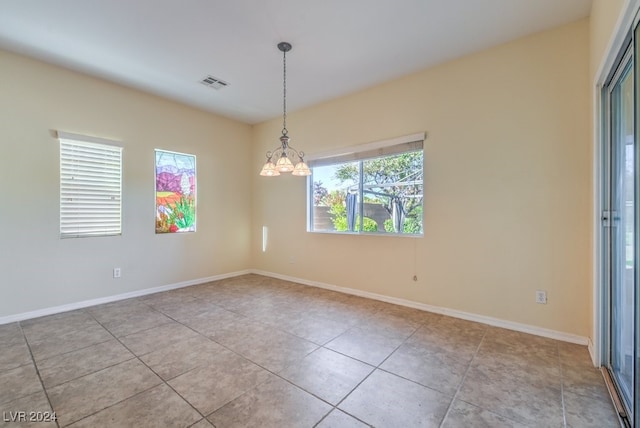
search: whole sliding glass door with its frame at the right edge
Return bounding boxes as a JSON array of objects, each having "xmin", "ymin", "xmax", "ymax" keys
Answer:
[{"xmin": 602, "ymin": 20, "xmax": 640, "ymax": 426}]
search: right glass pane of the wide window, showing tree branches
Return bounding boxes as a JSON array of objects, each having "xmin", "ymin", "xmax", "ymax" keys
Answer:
[{"xmin": 362, "ymin": 150, "xmax": 423, "ymax": 234}]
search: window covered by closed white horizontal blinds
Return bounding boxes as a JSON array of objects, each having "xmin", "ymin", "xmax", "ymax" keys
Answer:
[{"xmin": 58, "ymin": 132, "xmax": 122, "ymax": 238}]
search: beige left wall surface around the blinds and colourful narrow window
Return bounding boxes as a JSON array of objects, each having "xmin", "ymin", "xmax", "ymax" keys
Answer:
[{"xmin": 0, "ymin": 51, "xmax": 251, "ymax": 317}]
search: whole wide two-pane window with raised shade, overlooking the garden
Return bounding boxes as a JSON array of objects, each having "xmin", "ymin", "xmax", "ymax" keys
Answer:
[{"xmin": 309, "ymin": 134, "xmax": 424, "ymax": 235}]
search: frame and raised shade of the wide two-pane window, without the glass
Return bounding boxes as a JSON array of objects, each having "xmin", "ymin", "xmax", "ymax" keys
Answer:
[{"xmin": 307, "ymin": 132, "xmax": 427, "ymax": 238}]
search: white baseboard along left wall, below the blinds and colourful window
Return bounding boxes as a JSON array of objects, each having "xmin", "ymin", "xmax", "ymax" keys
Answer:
[{"xmin": 0, "ymin": 270, "xmax": 251, "ymax": 325}]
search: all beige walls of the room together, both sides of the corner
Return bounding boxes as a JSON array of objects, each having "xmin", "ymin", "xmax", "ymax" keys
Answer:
[{"xmin": 0, "ymin": 9, "xmax": 622, "ymax": 342}]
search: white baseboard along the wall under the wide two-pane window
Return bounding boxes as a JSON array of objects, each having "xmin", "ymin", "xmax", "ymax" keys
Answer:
[{"xmin": 250, "ymin": 269, "xmax": 590, "ymax": 345}]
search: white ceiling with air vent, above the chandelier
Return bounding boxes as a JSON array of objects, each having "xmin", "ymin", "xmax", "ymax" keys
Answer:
[{"xmin": 0, "ymin": 0, "xmax": 592, "ymax": 123}]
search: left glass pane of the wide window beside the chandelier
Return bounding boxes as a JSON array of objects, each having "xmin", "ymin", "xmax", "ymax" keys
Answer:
[{"xmin": 311, "ymin": 162, "xmax": 360, "ymax": 232}]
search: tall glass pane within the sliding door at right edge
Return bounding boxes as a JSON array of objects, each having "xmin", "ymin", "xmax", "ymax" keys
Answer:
[{"xmin": 611, "ymin": 59, "xmax": 636, "ymax": 409}]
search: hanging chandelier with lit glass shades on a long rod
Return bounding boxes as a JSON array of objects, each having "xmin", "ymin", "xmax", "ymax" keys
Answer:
[{"xmin": 260, "ymin": 42, "xmax": 311, "ymax": 177}]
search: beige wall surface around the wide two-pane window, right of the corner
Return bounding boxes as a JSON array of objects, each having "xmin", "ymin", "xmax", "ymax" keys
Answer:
[{"xmin": 251, "ymin": 20, "xmax": 591, "ymax": 336}]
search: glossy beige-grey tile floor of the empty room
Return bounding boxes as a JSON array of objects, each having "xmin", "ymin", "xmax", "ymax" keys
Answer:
[{"xmin": 0, "ymin": 275, "xmax": 618, "ymax": 428}]
